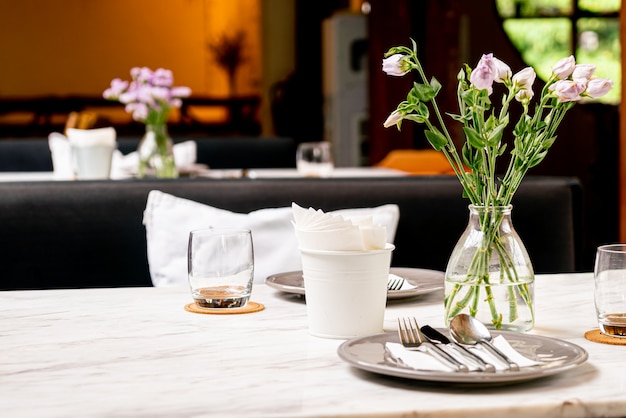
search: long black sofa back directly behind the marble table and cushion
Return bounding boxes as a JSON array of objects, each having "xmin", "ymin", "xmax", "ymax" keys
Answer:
[{"xmin": 0, "ymin": 176, "xmax": 580, "ymax": 290}]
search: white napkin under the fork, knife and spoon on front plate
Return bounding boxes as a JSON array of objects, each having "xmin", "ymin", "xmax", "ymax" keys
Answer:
[{"xmin": 386, "ymin": 335, "xmax": 541, "ymax": 372}]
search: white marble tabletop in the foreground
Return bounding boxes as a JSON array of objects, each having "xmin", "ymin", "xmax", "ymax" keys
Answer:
[{"xmin": 0, "ymin": 274, "xmax": 626, "ymax": 418}]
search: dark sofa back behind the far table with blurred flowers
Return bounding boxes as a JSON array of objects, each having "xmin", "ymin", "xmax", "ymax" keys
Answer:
[{"xmin": 0, "ymin": 136, "xmax": 296, "ymax": 171}]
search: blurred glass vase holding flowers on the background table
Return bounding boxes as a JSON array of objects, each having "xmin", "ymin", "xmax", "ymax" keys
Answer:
[{"xmin": 137, "ymin": 124, "xmax": 178, "ymax": 178}]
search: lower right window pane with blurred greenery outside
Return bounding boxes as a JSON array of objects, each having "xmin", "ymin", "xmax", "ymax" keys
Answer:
[{"xmin": 576, "ymin": 18, "xmax": 621, "ymax": 104}]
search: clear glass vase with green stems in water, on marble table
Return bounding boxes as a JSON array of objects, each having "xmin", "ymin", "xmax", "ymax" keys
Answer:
[{"xmin": 444, "ymin": 205, "xmax": 535, "ymax": 332}]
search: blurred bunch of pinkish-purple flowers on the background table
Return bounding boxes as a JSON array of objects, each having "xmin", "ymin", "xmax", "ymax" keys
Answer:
[{"xmin": 103, "ymin": 67, "xmax": 191, "ymax": 124}]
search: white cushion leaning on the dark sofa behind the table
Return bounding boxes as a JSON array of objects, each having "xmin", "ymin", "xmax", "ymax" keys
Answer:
[{"xmin": 143, "ymin": 190, "xmax": 400, "ymax": 286}]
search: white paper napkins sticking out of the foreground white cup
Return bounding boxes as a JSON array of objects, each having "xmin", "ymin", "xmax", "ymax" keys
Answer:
[{"xmin": 291, "ymin": 203, "xmax": 387, "ymax": 251}]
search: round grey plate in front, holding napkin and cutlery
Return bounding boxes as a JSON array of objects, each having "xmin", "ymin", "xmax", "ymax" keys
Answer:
[{"xmin": 337, "ymin": 329, "xmax": 589, "ymax": 384}]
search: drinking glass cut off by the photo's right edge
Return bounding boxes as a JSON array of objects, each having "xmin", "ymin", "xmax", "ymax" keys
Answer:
[{"xmin": 594, "ymin": 244, "xmax": 626, "ymax": 338}]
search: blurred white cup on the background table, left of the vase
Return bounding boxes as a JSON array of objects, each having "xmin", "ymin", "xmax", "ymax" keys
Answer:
[{"xmin": 67, "ymin": 128, "xmax": 116, "ymax": 180}]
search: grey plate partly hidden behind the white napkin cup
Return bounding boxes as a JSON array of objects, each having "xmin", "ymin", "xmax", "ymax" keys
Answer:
[{"xmin": 265, "ymin": 267, "xmax": 445, "ymax": 299}]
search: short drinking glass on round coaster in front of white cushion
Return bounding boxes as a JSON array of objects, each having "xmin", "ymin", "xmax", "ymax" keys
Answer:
[{"xmin": 187, "ymin": 228, "xmax": 254, "ymax": 308}]
